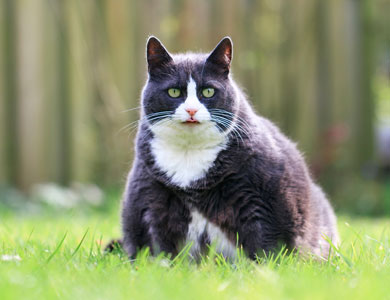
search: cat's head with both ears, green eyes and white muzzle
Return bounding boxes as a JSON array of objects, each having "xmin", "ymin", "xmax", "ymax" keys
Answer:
[{"xmin": 142, "ymin": 37, "xmax": 238, "ymax": 142}]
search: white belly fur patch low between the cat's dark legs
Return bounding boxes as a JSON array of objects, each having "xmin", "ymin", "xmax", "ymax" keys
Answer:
[{"xmin": 186, "ymin": 210, "xmax": 236, "ymax": 258}]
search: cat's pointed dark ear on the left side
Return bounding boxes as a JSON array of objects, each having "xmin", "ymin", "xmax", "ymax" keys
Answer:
[{"xmin": 146, "ymin": 36, "xmax": 172, "ymax": 73}]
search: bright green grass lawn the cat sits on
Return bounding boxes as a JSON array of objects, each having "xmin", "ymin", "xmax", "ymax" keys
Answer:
[{"xmin": 0, "ymin": 191, "xmax": 390, "ymax": 299}]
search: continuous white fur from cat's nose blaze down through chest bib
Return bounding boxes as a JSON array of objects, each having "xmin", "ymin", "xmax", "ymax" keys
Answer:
[{"xmin": 151, "ymin": 78, "xmax": 226, "ymax": 188}]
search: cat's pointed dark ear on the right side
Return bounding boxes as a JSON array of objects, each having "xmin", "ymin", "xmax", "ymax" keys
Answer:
[{"xmin": 206, "ymin": 37, "xmax": 233, "ymax": 75}]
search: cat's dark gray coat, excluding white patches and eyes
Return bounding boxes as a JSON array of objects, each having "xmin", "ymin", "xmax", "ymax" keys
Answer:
[{"xmin": 122, "ymin": 37, "xmax": 338, "ymax": 258}]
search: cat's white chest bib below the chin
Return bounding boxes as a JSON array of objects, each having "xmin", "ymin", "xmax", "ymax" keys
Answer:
[{"xmin": 151, "ymin": 138, "xmax": 224, "ymax": 188}]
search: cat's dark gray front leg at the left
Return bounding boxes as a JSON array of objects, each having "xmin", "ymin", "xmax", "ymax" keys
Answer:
[{"xmin": 122, "ymin": 168, "xmax": 189, "ymax": 257}]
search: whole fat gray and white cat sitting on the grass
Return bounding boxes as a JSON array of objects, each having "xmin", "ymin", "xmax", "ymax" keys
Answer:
[{"xmin": 122, "ymin": 37, "xmax": 338, "ymax": 258}]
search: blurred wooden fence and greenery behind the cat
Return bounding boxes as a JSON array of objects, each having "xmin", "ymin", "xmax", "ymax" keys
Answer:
[{"xmin": 0, "ymin": 0, "xmax": 390, "ymax": 214}]
